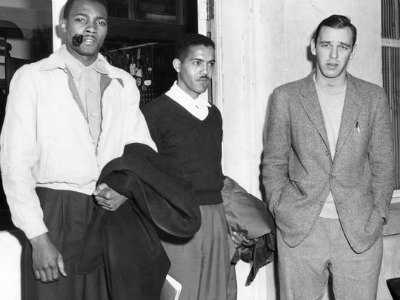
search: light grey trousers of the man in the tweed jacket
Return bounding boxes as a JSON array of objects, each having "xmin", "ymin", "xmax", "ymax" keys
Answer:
[{"xmin": 277, "ymin": 218, "xmax": 383, "ymax": 300}]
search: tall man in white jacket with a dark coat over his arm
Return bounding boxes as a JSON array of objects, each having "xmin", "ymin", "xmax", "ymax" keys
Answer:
[{"xmin": 1, "ymin": 0, "xmax": 155, "ymax": 300}]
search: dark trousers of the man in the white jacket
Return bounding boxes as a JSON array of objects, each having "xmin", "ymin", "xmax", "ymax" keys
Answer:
[{"xmin": 21, "ymin": 188, "xmax": 109, "ymax": 300}]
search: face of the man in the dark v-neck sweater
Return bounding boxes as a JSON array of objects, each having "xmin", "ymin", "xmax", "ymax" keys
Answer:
[{"xmin": 173, "ymin": 45, "xmax": 215, "ymax": 99}]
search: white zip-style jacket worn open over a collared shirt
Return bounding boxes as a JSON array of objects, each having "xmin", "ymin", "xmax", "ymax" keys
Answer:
[{"xmin": 1, "ymin": 47, "xmax": 155, "ymax": 238}]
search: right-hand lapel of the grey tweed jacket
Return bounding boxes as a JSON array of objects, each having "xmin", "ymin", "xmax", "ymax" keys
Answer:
[{"xmin": 334, "ymin": 73, "xmax": 362, "ymax": 159}]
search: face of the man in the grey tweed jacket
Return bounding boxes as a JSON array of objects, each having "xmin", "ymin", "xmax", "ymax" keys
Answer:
[{"xmin": 311, "ymin": 26, "xmax": 353, "ymax": 82}]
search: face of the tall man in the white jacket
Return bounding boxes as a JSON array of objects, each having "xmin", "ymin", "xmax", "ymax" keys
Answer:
[{"xmin": 62, "ymin": 0, "xmax": 107, "ymax": 65}]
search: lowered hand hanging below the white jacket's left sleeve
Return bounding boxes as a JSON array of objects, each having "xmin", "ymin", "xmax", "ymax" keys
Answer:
[{"xmin": 30, "ymin": 233, "xmax": 67, "ymax": 282}]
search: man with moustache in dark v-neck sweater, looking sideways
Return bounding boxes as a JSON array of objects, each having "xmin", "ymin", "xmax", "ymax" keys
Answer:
[{"xmin": 143, "ymin": 34, "xmax": 230, "ymax": 300}]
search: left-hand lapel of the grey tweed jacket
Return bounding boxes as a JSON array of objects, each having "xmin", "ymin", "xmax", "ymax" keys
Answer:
[{"xmin": 300, "ymin": 72, "xmax": 329, "ymax": 150}]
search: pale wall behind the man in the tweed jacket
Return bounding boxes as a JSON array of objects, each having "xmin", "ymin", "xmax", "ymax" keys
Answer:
[{"xmin": 213, "ymin": 0, "xmax": 382, "ymax": 300}]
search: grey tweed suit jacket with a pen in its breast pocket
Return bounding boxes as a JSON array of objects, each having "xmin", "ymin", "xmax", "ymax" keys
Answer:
[{"xmin": 262, "ymin": 72, "xmax": 394, "ymax": 253}]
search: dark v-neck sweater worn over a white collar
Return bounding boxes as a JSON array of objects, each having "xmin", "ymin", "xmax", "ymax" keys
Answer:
[{"xmin": 142, "ymin": 94, "xmax": 223, "ymax": 205}]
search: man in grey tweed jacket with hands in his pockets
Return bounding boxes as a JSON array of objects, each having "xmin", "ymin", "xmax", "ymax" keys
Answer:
[{"xmin": 263, "ymin": 15, "xmax": 394, "ymax": 300}]
